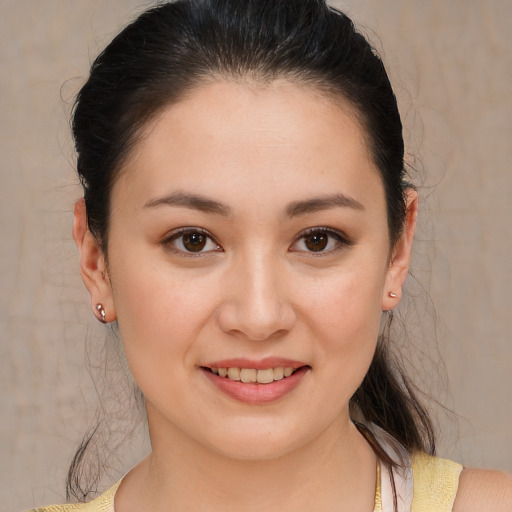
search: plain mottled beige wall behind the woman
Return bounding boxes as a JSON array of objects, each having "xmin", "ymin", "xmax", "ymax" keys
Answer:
[{"xmin": 0, "ymin": 0, "xmax": 512, "ymax": 511}]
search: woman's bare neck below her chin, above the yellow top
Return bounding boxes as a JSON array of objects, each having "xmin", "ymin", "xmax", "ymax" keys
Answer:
[{"xmin": 116, "ymin": 417, "xmax": 376, "ymax": 512}]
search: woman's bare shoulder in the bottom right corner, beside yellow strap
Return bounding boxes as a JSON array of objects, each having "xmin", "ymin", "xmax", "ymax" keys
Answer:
[{"xmin": 453, "ymin": 468, "xmax": 512, "ymax": 512}]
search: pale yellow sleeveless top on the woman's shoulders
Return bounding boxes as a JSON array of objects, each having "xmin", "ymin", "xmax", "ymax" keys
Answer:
[{"xmin": 28, "ymin": 453, "xmax": 462, "ymax": 512}]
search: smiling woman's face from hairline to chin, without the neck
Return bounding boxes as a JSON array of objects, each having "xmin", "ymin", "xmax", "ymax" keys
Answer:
[{"xmin": 79, "ymin": 82, "xmax": 412, "ymax": 458}]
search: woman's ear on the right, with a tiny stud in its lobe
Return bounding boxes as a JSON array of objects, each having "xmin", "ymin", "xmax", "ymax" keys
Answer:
[{"xmin": 382, "ymin": 188, "xmax": 418, "ymax": 311}]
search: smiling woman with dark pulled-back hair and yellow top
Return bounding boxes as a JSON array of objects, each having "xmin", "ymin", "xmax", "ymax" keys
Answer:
[{"xmin": 29, "ymin": 0, "xmax": 512, "ymax": 512}]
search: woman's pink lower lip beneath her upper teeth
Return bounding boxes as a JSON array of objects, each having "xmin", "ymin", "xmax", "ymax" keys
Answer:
[{"xmin": 201, "ymin": 366, "xmax": 310, "ymax": 405}]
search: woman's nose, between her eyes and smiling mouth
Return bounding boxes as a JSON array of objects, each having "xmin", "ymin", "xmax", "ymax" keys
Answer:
[{"xmin": 218, "ymin": 251, "xmax": 295, "ymax": 341}]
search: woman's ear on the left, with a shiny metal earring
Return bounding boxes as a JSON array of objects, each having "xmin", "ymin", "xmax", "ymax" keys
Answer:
[{"xmin": 73, "ymin": 199, "xmax": 116, "ymax": 322}]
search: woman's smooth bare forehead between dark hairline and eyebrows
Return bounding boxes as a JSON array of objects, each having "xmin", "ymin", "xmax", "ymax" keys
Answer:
[{"xmin": 115, "ymin": 81, "xmax": 382, "ymax": 213}]
